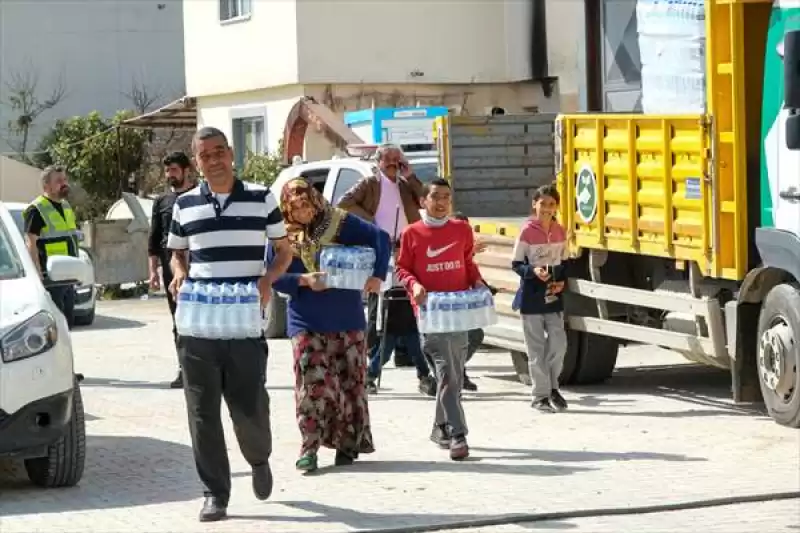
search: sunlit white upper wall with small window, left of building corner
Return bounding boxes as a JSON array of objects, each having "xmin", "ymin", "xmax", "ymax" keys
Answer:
[{"xmin": 183, "ymin": 0, "xmax": 298, "ymax": 96}]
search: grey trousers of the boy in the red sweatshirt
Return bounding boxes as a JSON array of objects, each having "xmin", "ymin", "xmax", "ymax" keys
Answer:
[{"xmin": 422, "ymin": 331, "xmax": 468, "ymax": 436}]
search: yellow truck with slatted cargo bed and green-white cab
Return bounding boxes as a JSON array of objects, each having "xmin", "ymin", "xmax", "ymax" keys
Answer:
[{"xmin": 437, "ymin": 0, "xmax": 800, "ymax": 428}]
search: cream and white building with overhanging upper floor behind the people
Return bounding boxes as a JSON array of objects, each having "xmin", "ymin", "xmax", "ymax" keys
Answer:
[{"xmin": 184, "ymin": 0, "xmax": 583, "ymax": 160}]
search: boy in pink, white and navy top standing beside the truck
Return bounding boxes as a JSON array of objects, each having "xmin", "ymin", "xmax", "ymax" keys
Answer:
[{"xmin": 511, "ymin": 185, "xmax": 569, "ymax": 413}]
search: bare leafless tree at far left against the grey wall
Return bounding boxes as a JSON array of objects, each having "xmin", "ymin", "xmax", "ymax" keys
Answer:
[{"xmin": 3, "ymin": 67, "xmax": 66, "ymax": 162}]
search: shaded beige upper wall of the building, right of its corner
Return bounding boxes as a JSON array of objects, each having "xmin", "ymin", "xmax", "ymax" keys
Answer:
[{"xmin": 297, "ymin": 0, "xmax": 530, "ymax": 84}]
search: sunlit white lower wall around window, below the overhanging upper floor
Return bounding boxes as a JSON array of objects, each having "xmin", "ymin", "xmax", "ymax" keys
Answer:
[{"xmin": 197, "ymin": 85, "xmax": 303, "ymax": 152}]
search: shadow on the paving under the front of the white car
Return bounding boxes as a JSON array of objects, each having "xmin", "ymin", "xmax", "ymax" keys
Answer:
[{"xmin": 0, "ymin": 436, "xmax": 198, "ymax": 517}]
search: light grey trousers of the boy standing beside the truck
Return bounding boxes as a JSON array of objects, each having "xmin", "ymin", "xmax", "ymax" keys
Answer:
[{"xmin": 522, "ymin": 313, "xmax": 567, "ymax": 400}]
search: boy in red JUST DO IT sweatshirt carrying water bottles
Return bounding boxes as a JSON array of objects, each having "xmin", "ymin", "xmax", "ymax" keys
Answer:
[{"xmin": 397, "ymin": 179, "xmax": 485, "ymax": 460}]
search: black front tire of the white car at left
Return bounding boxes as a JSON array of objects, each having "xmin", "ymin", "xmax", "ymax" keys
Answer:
[{"xmin": 25, "ymin": 383, "xmax": 86, "ymax": 488}]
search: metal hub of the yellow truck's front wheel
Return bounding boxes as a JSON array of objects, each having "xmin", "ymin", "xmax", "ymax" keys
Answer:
[{"xmin": 758, "ymin": 319, "xmax": 797, "ymax": 400}]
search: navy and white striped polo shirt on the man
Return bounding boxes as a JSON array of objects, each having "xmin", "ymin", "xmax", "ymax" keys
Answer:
[{"xmin": 167, "ymin": 179, "xmax": 286, "ymax": 283}]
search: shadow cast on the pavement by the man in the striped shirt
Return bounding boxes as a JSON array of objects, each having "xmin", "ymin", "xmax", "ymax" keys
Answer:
[{"xmin": 229, "ymin": 501, "xmax": 577, "ymax": 533}]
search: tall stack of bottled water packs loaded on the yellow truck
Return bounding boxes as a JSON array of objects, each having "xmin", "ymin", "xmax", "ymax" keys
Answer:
[{"xmin": 636, "ymin": 0, "xmax": 706, "ymax": 114}]
